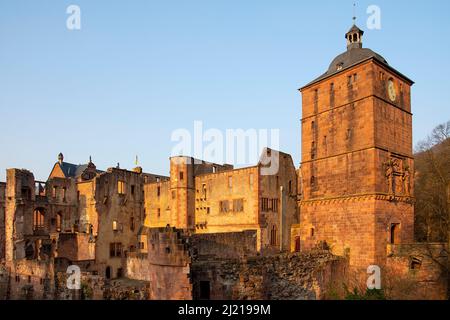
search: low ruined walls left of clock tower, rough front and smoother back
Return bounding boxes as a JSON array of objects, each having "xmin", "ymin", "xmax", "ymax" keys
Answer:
[{"xmin": 189, "ymin": 231, "xmax": 348, "ymax": 300}]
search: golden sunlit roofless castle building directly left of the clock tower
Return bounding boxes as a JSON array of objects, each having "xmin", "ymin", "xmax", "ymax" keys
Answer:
[{"xmin": 144, "ymin": 151, "xmax": 298, "ymax": 250}]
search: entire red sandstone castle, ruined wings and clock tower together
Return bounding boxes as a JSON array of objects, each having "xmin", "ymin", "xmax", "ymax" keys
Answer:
[{"xmin": 0, "ymin": 25, "xmax": 445, "ymax": 299}]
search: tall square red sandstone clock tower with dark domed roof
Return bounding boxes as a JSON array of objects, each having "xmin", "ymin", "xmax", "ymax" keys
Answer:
[{"xmin": 299, "ymin": 25, "xmax": 414, "ymax": 270}]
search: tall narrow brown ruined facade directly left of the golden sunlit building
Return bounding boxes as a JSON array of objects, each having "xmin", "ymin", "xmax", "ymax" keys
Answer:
[{"xmin": 93, "ymin": 168, "xmax": 144, "ymax": 278}]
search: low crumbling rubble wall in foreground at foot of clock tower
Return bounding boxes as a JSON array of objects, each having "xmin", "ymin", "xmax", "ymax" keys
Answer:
[{"xmin": 192, "ymin": 252, "xmax": 346, "ymax": 300}]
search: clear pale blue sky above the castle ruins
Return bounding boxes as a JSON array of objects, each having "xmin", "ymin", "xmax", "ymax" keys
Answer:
[{"xmin": 0, "ymin": 0, "xmax": 450, "ymax": 181}]
